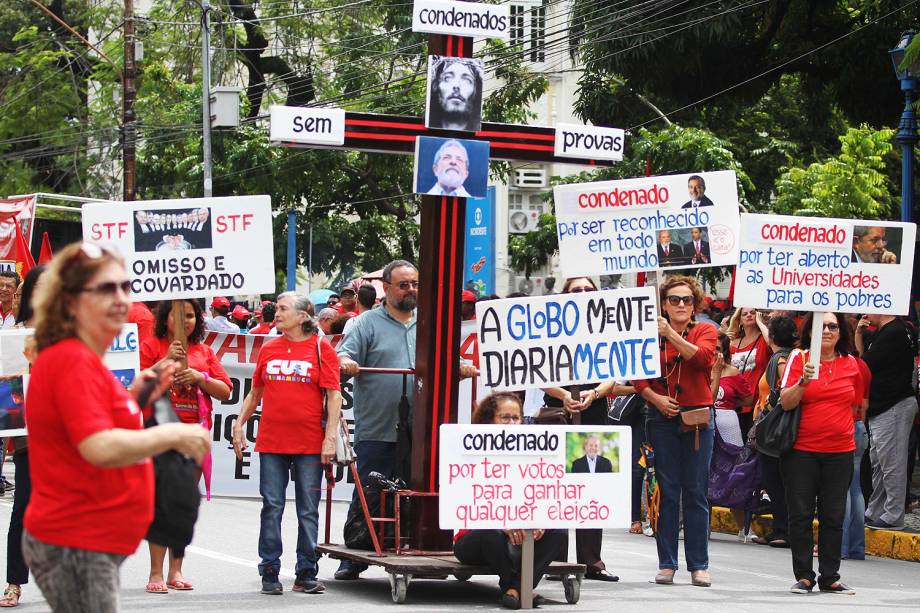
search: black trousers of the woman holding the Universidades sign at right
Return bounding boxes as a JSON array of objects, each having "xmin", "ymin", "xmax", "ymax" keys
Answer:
[{"xmin": 780, "ymin": 449, "xmax": 853, "ymax": 587}]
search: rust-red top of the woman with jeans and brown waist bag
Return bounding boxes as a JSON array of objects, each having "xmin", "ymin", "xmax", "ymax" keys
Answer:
[{"xmin": 633, "ymin": 324, "xmax": 719, "ymax": 407}]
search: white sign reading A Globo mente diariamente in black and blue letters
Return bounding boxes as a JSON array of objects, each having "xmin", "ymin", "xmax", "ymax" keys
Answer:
[{"xmin": 476, "ymin": 287, "xmax": 661, "ymax": 390}]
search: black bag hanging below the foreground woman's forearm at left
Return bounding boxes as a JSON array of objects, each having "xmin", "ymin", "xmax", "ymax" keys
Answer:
[{"xmin": 147, "ymin": 398, "xmax": 201, "ymax": 558}]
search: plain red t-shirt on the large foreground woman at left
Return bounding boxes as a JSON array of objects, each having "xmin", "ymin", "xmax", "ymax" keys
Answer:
[{"xmin": 25, "ymin": 339, "xmax": 153, "ymax": 555}]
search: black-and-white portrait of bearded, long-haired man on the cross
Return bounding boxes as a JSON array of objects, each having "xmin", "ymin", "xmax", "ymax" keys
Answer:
[{"xmin": 426, "ymin": 56, "xmax": 482, "ymax": 132}]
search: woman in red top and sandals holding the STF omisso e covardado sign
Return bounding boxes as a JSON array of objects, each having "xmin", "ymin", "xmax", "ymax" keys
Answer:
[{"xmin": 141, "ymin": 300, "xmax": 233, "ymax": 594}]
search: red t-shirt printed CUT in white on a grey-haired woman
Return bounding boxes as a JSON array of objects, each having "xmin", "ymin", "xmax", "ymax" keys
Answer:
[{"xmin": 252, "ymin": 336, "xmax": 339, "ymax": 454}]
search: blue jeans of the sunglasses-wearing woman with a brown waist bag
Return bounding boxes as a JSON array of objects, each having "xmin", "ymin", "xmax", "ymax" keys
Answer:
[{"xmin": 647, "ymin": 408, "xmax": 715, "ymax": 571}]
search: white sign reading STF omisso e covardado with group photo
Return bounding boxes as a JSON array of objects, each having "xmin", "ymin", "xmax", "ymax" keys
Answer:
[{"xmin": 83, "ymin": 196, "xmax": 275, "ymax": 300}]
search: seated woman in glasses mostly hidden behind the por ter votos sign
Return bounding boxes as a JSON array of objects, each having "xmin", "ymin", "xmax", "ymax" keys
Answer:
[{"xmin": 454, "ymin": 392, "xmax": 568, "ymax": 609}]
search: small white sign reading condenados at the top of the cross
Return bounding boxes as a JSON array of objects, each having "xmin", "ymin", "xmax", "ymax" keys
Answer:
[{"xmin": 412, "ymin": 0, "xmax": 511, "ymax": 40}]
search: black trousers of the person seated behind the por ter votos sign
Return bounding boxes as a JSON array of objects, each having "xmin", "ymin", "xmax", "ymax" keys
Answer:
[{"xmin": 454, "ymin": 530, "xmax": 568, "ymax": 593}]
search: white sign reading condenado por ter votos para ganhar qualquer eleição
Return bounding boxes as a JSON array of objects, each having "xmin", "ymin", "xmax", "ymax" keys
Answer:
[{"xmin": 438, "ymin": 424, "xmax": 632, "ymax": 530}]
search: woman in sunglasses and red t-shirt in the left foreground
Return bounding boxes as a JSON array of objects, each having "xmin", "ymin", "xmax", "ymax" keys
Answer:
[{"xmin": 23, "ymin": 243, "xmax": 211, "ymax": 613}]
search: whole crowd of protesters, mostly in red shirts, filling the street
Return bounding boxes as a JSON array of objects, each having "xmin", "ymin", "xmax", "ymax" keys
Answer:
[{"xmin": 0, "ymin": 243, "xmax": 920, "ymax": 611}]
